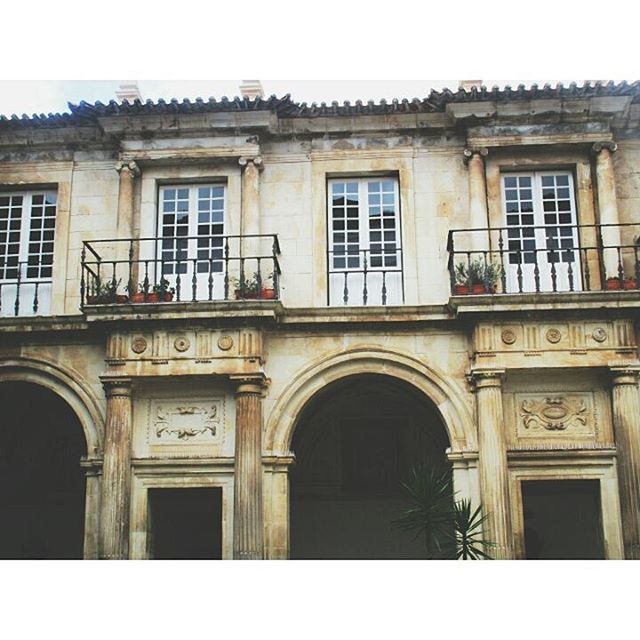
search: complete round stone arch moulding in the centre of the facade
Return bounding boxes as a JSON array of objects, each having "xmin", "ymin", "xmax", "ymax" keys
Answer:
[{"xmin": 264, "ymin": 346, "xmax": 476, "ymax": 455}]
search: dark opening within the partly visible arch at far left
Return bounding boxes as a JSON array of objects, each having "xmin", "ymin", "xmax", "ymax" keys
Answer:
[{"xmin": 0, "ymin": 381, "xmax": 86, "ymax": 559}]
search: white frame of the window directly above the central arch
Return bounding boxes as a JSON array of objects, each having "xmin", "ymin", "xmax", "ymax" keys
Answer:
[{"xmin": 326, "ymin": 175, "xmax": 404, "ymax": 306}]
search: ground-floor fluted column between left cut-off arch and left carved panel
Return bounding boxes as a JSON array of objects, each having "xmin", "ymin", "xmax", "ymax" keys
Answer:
[{"xmin": 100, "ymin": 378, "xmax": 132, "ymax": 560}]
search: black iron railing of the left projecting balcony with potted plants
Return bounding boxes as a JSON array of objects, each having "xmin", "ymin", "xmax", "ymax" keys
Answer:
[{"xmin": 80, "ymin": 234, "xmax": 281, "ymax": 307}]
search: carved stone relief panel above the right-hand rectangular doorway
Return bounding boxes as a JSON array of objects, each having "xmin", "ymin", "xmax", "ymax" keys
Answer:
[{"xmin": 515, "ymin": 392, "xmax": 598, "ymax": 439}]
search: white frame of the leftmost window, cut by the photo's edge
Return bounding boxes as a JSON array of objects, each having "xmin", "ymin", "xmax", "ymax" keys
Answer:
[{"xmin": 0, "ymin": 188, "xmax": 58, "ymax": 316}]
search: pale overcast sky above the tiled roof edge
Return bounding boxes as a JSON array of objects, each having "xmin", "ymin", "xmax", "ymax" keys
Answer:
[{"xmin": 0, "ymin": 78, "xmax": 616, "ymax": 116}]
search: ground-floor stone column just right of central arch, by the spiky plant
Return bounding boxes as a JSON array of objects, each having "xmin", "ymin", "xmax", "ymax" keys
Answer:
[{"xmin": 472, "ymin": 370, "xmax": 513, "ymax": 560}]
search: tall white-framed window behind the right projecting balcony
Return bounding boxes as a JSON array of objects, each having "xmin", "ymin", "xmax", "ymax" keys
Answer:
[{"xmin": 502, "ymin": 171, "xmax": 581, "ymax": 291}]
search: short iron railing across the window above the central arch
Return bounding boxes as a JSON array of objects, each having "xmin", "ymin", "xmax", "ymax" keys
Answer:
[{"xmin": 327, "ymin": 247, "xmax": 404, "ymax": 306}]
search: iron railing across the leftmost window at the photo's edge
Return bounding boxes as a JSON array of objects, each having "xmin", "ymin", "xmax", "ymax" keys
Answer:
[{"xmin": 0, "ymin": 257, "xmax": 51, "ymax": 317}]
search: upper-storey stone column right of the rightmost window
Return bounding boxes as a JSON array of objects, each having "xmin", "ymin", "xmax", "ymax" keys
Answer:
[{"xmin": 593, "ymin": 142, "xmax": 624, "ymax": 278}]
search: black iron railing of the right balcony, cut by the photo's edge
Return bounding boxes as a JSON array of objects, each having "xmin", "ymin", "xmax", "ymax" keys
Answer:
[{"xmin": 447, "ymin": 224, "xmax": 640, "ymax": 295}]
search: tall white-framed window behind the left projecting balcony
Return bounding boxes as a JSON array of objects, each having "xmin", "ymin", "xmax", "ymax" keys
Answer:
[{"xmin": 158, "ymin": 184, "xmax": 226, "ymax": 299}]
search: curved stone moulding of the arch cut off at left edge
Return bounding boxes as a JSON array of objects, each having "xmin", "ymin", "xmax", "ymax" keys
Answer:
[{"xmin": 0, "ymin": 356, "xmax": 104, "ymax": 456}]
